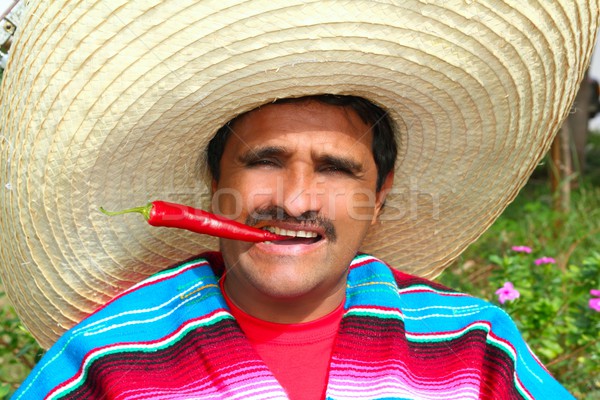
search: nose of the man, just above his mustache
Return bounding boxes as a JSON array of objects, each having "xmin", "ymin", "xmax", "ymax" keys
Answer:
[{"xmin": 278, "ymin": 167, "xmax": 325, "ymax": 217}]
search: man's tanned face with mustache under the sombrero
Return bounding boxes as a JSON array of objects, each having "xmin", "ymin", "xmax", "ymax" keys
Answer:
[{"xmin": 213, "ymin": 101, "xmax": 392, "ymax": 318}]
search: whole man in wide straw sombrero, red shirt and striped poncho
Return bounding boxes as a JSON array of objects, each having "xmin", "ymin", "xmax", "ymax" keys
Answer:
[{"xmin": 2, "ymin": 1, "xmax": 598, "ymax": 399}]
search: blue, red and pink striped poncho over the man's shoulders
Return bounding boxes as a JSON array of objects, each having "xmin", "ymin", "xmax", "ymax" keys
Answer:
[{"xmin": 13, "ymin": 254, "xmax": 572, "ymax": 400}]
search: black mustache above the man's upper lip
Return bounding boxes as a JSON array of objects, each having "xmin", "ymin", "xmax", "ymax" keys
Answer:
[{"xmin": 245, "ymin": 206, "xmax": 337, "ymax": 242}]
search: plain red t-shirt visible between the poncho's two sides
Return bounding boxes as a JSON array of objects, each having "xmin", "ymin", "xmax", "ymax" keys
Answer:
[{"xmin": 221, "ymin": 287, "xmax": 344, "ymax": 400}]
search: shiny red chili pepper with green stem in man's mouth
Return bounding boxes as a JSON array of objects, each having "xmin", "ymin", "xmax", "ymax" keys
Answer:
[{"xmin": 100, "ymin": 201, "xmax": 289, "ymax": 242}]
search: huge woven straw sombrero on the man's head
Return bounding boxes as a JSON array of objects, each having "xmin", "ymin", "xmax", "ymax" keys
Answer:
[{"xmin": 0, "ymin": 0, "xmax": 599, "ymax": 346}]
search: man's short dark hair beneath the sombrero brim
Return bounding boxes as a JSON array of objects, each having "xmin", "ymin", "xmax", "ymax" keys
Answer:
[{"xmin": 206, "ymin": 94, "xmax": 398, "ymax": 191}]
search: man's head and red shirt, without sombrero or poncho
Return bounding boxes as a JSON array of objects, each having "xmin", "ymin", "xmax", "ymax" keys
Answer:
[{"xmin": 207, "ymin": 96, "xmax": 396, "ymax": 399}]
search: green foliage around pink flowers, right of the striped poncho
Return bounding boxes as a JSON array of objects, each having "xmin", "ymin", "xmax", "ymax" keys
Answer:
[{"xmin": 439, "ymin": 183, "xmax": 600, "ymax": 399}]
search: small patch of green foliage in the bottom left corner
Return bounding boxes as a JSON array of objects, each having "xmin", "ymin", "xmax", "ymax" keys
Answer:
[{"xmin": 0, "ymin": 286, "xmax": 43, "ymax": 400}]
